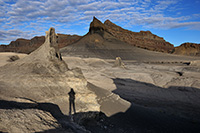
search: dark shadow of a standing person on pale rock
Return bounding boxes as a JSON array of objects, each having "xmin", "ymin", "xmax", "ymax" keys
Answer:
[{"xmin": 68, "ymin": 88, "xmax": 76, "ymax": 115}]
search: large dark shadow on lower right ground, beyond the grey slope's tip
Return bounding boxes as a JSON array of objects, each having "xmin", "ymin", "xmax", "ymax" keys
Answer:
[{"xmin": 109, "ymin": 78, "xmax": 200, "ymax": 132}]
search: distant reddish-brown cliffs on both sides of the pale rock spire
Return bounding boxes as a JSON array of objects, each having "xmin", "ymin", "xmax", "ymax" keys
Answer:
[{"xmin": 0, "ymin": 34, "xmax": 81, "ymax": 54}]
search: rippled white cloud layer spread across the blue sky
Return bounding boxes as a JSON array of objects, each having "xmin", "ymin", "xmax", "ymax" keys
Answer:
[{"xmin": 0, "ymin": 0, "xmax": 200, "ymax": 43}]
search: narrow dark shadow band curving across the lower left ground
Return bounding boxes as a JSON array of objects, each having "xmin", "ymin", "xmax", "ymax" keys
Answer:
[{"xmin": 0, "ymin": 100, "xmax": 84, "ymax": 133}]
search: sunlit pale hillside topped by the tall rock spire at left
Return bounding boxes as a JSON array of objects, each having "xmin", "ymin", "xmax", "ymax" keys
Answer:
[{"xmin": 0, "ymin": 28, "xmax": 100, "ymax": 114}]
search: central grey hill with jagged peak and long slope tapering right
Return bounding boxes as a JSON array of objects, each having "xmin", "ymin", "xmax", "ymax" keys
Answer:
[{"xmin": 60, "ymin": 17, "xmax": 198, "ymax": 61}]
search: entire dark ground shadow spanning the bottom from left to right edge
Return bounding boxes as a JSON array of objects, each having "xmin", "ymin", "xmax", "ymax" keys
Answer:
[{"xmin": 0, "ymin": 79, "xmax": 200, "ymax": 133}]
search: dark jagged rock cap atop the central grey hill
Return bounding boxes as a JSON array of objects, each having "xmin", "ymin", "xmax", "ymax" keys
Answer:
[{"xmin": 89, "ymin": 17, "xmax": 106, "ymax": 34}]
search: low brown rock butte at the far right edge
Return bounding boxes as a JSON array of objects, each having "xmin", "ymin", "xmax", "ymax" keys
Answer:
[{"xmin": 173, "ymin": 43, "xmax": 200, "ymax": 56}]
